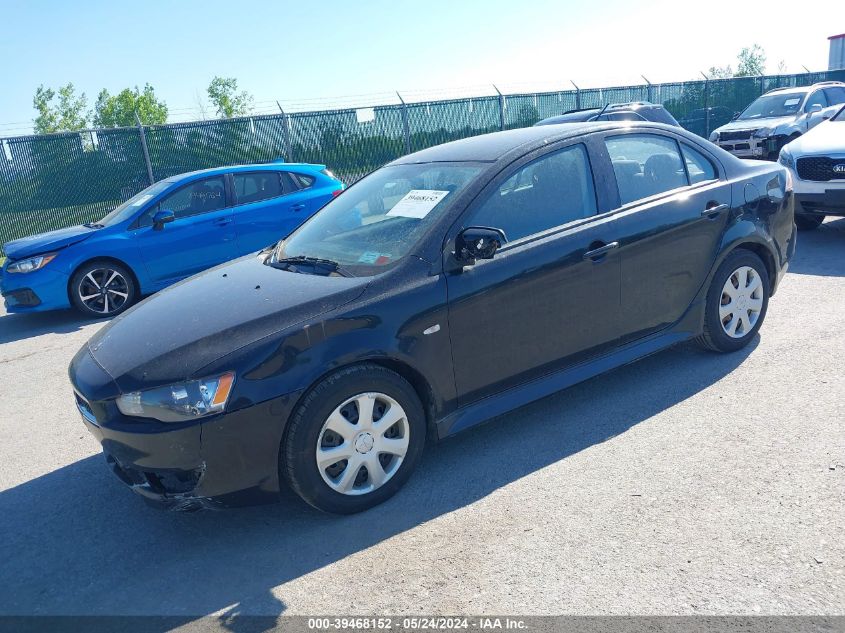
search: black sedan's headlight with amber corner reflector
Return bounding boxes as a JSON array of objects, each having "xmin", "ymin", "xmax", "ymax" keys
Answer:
[{"xmin": 117, "ymin": 372, "xmax": 235, "ymax": 422}]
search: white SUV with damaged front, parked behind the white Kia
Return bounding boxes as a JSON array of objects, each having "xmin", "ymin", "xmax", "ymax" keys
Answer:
[{"xmin": 710, "ymin": 81, "xmax": 845, "ymax": 160}]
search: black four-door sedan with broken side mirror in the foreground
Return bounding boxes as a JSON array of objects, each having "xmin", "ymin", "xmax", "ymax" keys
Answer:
[{"xmin": 70, "ymin": 123, "xmax": 795, "ymax": 513}]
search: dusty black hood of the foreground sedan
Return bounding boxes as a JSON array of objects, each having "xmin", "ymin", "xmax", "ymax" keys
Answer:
[{"xmin": 83, "ymin": 255, "xmax": 369, "ymax": 392}]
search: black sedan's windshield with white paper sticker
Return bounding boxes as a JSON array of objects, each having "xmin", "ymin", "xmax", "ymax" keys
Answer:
[{"xmin": 272, "ymin": 163, "xmax": 481, "ymax": 275}]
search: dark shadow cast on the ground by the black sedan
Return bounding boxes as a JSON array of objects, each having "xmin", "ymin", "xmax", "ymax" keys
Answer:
[{"xmin": 0, "ymin": 339, "xmax": 758, "ymax": 631}]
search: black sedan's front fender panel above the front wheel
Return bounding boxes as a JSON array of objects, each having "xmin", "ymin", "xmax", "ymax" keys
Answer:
[{"xmin": 200, "ymin": 264, "xmax": 455, "ymax": 417}]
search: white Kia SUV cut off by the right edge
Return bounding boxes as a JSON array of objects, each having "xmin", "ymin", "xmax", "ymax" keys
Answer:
[{"xmin": 778, "ymin": 107, "xmax": 845, "ymax": 229}]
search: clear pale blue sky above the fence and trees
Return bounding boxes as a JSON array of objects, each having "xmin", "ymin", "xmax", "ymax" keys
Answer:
[{"xmin": 0, "ymin": 0, "xmax": 845, "ymax": 137}]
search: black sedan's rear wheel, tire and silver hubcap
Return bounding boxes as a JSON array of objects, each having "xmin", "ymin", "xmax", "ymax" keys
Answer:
[{"xmin": 696, "ymin": 248, "xmax": 771, "ymax": 352}]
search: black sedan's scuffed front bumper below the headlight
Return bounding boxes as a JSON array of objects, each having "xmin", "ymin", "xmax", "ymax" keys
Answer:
[{"xmin": 70, "ymin": 348, "xmax": 299, "ymax": 511}]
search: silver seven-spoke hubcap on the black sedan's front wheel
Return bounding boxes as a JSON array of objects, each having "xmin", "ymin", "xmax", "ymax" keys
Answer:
[{"xmin": 316, "ymin": 393, "xmax": 410, "ymax": 495}]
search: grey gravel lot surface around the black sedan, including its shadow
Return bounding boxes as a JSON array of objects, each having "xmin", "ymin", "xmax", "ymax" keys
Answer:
[{"xmin": 0, "ymin": 220, "xmax": 845, "ymax": 620}]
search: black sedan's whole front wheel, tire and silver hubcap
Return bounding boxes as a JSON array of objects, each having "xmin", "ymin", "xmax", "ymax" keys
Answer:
[{"xmin": 279, "ymin": 364, "xmax": 427, "ymax": 514}]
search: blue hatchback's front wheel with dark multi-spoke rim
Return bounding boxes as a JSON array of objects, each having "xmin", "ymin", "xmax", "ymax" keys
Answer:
[{"xmin": 69, "ymin": 260, "xmax": 138, "ymax": 318}]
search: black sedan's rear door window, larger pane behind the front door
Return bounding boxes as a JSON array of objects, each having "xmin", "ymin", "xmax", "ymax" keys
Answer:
[{"xmin": 605, "ymin": 134, "xmax": 688, "ymax": 205}]
